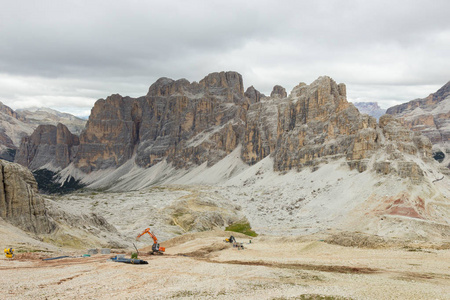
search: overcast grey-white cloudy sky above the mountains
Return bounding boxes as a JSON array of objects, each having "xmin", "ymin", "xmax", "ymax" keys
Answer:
[{"xmin": 0, "ymin": 0, "xmax": 450, "ymax": 116}]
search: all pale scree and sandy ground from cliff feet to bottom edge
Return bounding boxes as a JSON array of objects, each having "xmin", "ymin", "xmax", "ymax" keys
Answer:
[{"xmin": 0, "ymin": 155, "xmax": 450, "ymax": 299}]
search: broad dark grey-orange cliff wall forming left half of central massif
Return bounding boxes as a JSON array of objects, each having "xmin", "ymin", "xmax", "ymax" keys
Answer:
[{"xmin": 75, "ymin": 72, "xmax": 248, "ymax": 172}]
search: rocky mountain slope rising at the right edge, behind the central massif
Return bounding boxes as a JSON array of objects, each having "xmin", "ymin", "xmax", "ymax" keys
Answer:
[{"xmin": 386, "ymin": 81, "xmax": 450, "ymax": 168}]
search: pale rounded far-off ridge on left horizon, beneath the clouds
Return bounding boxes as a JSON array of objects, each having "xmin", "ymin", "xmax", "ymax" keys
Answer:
[{"xmin": 16, "ymin": 107, "xmax": 87, "ymax": 135}]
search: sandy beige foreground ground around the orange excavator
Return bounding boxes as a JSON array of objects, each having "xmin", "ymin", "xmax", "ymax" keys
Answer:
[{"xmin": 0, "ymin": 232, "xmax": 450, "ymax": 299}]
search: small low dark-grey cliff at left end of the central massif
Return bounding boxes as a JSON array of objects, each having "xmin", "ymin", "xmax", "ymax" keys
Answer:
[{"xmin": 15, "ymin": 124, "xmax": 80, "ymax": 170}]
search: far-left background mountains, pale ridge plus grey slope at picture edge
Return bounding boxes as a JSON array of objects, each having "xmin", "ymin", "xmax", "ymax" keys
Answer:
[{"xmin": 0, "ymin": 102, "xmax": 86, "ymax": 161}]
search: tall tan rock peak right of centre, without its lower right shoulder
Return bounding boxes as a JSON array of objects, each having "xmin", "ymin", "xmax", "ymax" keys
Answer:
[{"xmin": 275, "ymin": 77, "xmax": 377, "ymax": 171}]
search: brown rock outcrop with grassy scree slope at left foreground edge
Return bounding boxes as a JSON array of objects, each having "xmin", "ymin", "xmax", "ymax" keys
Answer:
[{"xmin": 0, "ymin": 159, "xmax": 124, "ymax": 250}]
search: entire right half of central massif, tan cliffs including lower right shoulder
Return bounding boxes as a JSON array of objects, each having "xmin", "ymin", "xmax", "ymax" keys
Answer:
[{"xmin": 242, "ymin": 76, "xmax": 431, "ymax": 182}]
